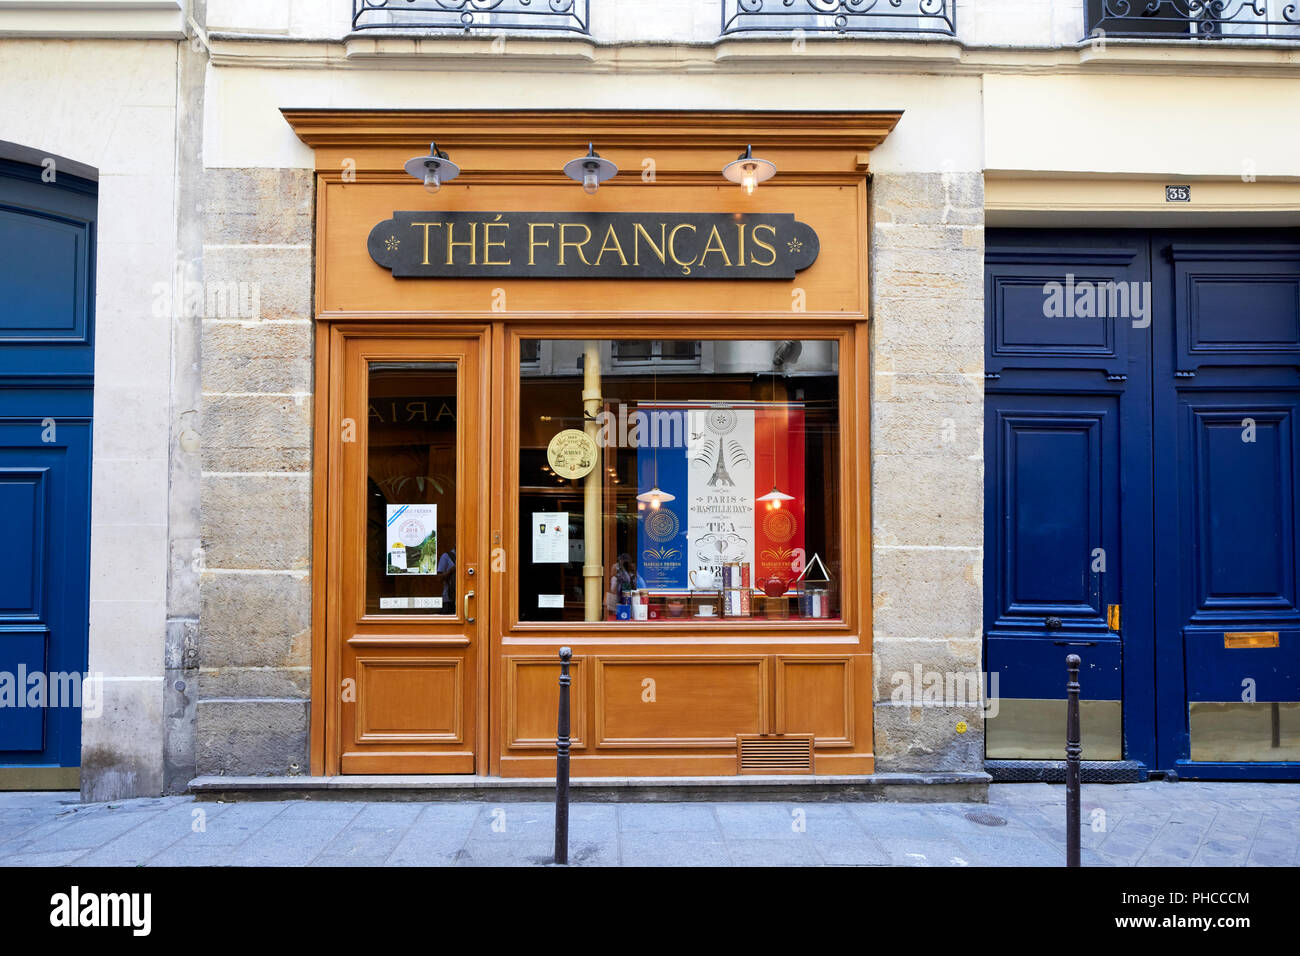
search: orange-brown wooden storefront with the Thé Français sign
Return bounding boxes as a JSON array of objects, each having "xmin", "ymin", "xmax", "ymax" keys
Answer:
[{"xmin": 285, "ymin": 109, "xmax": 900, "ymax": 777}]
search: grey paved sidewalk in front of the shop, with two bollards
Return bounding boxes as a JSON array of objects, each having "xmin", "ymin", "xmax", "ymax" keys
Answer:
[{"xmin": 0, "ymin": 782, "xmax": 1300, "ymax": 866}]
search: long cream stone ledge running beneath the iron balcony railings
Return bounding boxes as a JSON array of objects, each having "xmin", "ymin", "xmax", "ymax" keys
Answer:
[{"xmin": 208, "ymin": 33, "xmax": 1300, "ymax": 77}]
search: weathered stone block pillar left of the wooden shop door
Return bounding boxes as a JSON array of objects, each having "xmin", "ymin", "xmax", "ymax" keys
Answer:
[{"xmin": 195, "ymin": 169, "xmax": 313, "ymax": 774}]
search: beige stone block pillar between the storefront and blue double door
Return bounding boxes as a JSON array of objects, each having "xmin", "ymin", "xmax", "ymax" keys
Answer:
[{"xmin": 871, "ymin": 172, "xmax": 984, "ymax": 771}]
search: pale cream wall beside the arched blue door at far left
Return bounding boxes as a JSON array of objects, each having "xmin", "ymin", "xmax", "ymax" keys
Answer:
[{"xmin": 0, "ymin": 40, "xmax": 177, "ymax": 799}]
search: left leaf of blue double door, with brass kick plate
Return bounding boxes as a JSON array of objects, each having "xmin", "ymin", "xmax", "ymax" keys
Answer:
[{"xmin": 984, "ymin": 230, "xmax": 1154, "ymax": 762}]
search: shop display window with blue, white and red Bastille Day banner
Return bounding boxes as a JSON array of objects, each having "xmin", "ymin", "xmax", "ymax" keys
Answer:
[{"xmin": 516, "ymin": 338, "xmax": 842, "ymax": 628}]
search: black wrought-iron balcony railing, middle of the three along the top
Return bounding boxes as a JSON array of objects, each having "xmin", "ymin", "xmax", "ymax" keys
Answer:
[{"xmin": 723, "ymin": 0, "xmax": 957, "ymax": 36}]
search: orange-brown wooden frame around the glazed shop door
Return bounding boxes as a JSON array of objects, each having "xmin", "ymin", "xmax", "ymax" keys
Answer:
[{"xmin": 309, "ymin": 316, "xmax": 494, "ymax": 777}]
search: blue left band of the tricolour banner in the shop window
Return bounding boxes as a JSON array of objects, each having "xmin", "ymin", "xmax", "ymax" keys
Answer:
[{"xmin": 637, "ymin": 406, "xmax": 690, "ymax": 591}]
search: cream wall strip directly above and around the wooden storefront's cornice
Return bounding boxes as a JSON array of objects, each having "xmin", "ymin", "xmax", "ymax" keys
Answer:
[{"xmin": 204, "ymin": 66, "xmax": 983, "ymax": 172}]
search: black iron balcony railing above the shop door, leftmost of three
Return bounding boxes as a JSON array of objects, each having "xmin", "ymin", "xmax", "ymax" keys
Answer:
[{"xmin": 352, "ymin": 0, "xmax": 592, "ymax": 35}]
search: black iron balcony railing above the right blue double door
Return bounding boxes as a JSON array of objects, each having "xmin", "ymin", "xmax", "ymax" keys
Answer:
[{"xmin": 1086, "ymin": 0, "xmax": 1300, "ymax": 40}]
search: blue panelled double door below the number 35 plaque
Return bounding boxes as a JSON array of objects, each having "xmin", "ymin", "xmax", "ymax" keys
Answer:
[{"xmin": 984, "ymin": 230, "xmax": 1300, "ymax": 778}]
